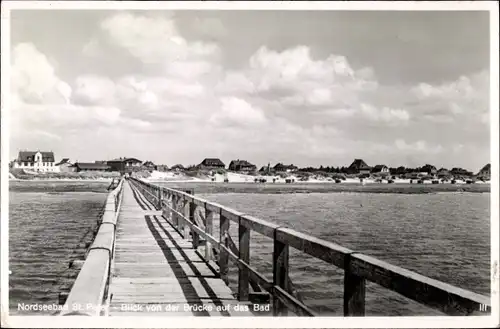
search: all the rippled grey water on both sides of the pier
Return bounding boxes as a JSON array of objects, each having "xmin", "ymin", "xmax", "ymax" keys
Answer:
[{"xmin": 9, "ymin": 179, "xmax": 490, "ymax": 315}]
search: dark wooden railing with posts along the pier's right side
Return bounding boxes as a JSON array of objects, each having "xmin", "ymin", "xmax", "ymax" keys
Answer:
[{"xmin": 127, "ymin": 178, "xmax": 491, "ymax": 316}]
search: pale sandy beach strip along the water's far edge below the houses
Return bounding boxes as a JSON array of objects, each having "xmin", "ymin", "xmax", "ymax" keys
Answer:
[{"xmin": 9, "ymin": 171, "xmax": 491, "ymax": 194}]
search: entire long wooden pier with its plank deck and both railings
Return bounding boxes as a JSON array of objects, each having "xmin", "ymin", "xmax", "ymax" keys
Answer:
[{"xmin": 60, "ymin": 178, "xmax": 491, "ymax": 316}]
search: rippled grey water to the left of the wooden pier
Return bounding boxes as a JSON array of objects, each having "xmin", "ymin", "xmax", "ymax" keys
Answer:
[{"xmin": 9, "ymin": 182, "xmax": 109, "ymax": 313}]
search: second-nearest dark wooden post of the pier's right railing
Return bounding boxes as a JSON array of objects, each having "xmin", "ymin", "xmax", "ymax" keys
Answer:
[{"xmin": 273, "ymin": 230, "xmax": 289, "ymax": 316}]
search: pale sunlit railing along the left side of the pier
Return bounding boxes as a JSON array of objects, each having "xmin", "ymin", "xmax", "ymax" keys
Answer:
[{"xmin": 60, "ymin": 179, "xmax": 124, "ymax": 316}]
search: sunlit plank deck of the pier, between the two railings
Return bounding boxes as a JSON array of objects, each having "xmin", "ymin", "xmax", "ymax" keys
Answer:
[{"xmin": 109, "ymin": 182, "xmax": 252, "ymax": 316}]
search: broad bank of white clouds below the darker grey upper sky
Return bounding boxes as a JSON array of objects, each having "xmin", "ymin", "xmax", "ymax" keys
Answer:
[{"xmin": 12, "ymin": 12, "xmax": 489, "ymax": 169}]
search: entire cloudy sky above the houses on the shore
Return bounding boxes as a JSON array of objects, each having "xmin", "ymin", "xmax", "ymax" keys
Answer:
[{"xmin": 10, "ymin": 10, "xmax": 490, "ymax": 171}]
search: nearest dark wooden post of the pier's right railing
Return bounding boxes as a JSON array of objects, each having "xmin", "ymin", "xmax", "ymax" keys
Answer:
[{"xmin": 344, "ymin": 254, "xmax": 366, "ymax": 316}]
